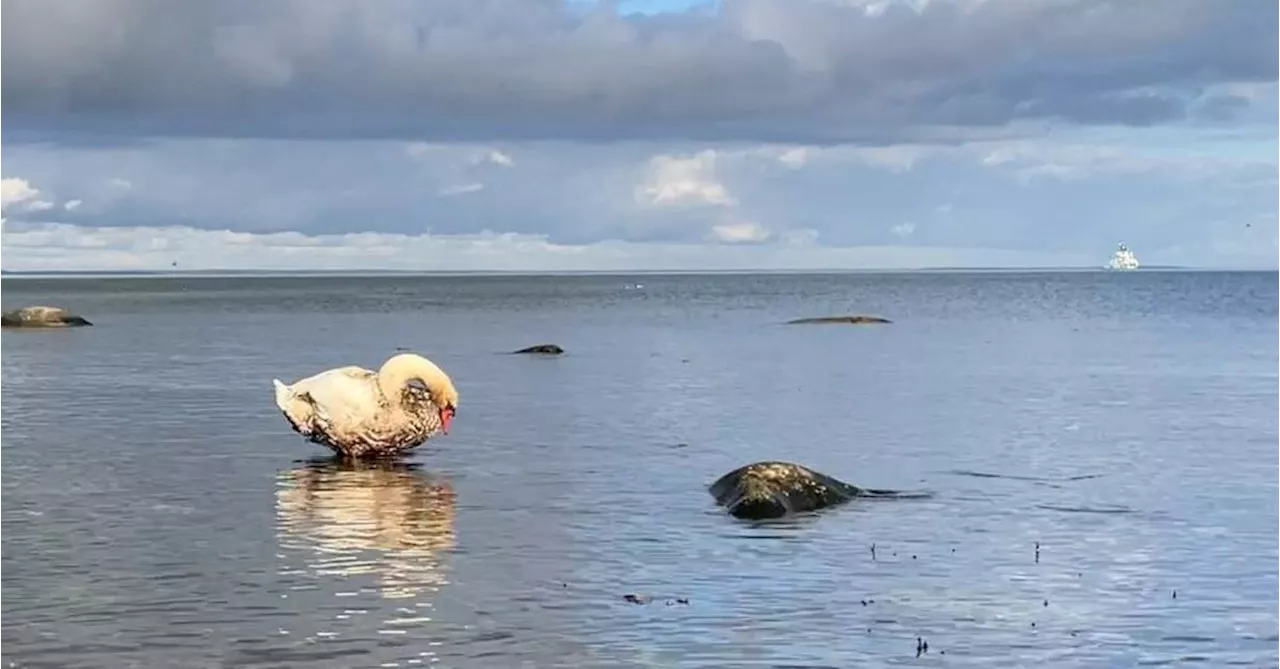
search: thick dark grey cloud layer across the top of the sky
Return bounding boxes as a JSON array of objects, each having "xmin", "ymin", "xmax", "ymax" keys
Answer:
[{"xmin": 0, "ymin": 0, "xmax": 1280, "ymax": 143}]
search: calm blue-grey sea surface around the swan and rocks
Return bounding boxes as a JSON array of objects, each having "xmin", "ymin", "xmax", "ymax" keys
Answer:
[{"xmin": 0, "ymin": 271, "xmax": 1280, "ymax": 669}]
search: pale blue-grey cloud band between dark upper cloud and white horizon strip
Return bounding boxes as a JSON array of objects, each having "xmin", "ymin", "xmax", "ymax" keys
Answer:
[{"xmin": 0, "ymin": 129, "xmax": 1280, "ymax": 266}]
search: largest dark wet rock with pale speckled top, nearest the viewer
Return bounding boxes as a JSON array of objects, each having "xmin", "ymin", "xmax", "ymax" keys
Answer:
[{"xmin": 708, "ymin": 462, "xmax": 928, "ymax": 521}]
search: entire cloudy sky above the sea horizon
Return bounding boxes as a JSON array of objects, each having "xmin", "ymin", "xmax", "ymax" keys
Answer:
[{"xmin": 0, "ymin": 0, "xmax": 1280, "ymax": 271}]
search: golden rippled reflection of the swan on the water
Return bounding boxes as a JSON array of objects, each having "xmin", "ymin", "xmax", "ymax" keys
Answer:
[{"xmin": 275, "ymin": 458, "xmax": 456, "ymax": 599}]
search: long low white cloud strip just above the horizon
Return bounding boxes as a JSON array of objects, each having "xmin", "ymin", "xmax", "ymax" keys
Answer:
[{"xmin": 5, "ymin": 224, "xmax": 1096, "ymax": 271}]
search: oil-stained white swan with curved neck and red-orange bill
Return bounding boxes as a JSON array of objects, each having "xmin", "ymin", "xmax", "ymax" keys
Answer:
[{"xmin": 271, "ymin": 353, "xmax": 458, "ymax": 458}]
